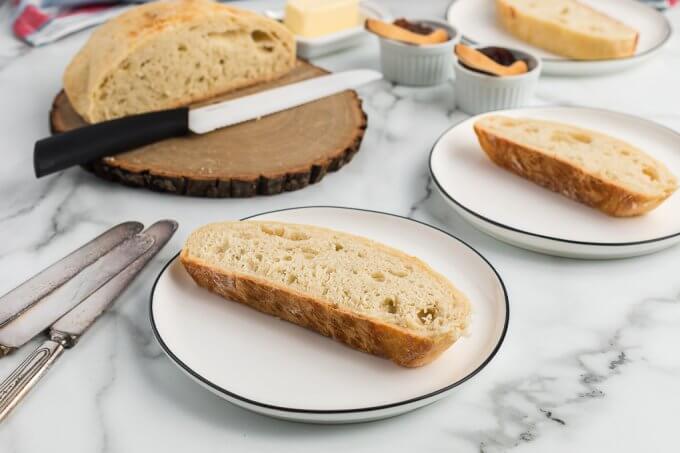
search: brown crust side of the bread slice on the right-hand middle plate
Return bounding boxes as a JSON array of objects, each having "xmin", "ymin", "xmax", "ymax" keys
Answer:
[{"xmin": 474, "ymin": 123, "xmax": 670, "ymax": 217}]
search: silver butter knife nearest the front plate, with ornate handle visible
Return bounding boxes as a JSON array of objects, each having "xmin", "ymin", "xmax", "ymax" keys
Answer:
[{"xmin": 0, "ymin": 220, "xmax": 177, "ymax": 422}]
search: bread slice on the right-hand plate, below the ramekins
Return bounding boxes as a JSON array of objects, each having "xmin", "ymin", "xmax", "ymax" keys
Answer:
[{"xmin": 474, "ymin": 115, "xmax": 678, "ymax": 217}]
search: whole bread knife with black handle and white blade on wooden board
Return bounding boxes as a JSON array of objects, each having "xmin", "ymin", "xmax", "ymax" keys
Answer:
[{"xmin": 33, "ymin": 69, "xmax": 382, "ymax": 178}]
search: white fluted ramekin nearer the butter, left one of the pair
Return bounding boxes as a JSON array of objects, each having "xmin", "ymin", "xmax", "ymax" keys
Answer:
[{"xmin": 379, "ymin": 19, "xmax": 460, "ymax": 86}]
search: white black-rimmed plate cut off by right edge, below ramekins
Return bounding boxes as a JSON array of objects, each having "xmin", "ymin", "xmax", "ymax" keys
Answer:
[{"xmin": 430, "ymin": 107, "xmax": 680, "ymax": 259}]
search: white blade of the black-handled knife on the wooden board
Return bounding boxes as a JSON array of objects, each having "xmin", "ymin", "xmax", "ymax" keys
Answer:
[{"xmin": 189, "ymin": 69, "xmax": 382, "ymax": 134}]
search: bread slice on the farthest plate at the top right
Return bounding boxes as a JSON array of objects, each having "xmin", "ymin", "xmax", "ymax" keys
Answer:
[{"xmin": 496, "ymin": 0, "xmax": 639, "ymax": 60}]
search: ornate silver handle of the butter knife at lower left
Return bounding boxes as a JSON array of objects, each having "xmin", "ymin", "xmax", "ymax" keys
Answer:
[{"xmin": 0, "ymin": 340, "xmax": 64, "ymax": 422}]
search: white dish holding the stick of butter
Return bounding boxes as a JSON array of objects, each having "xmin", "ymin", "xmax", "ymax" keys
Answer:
[{"xmin": 264, "ymin": 1, "xmax": 391, "ymax": 59}]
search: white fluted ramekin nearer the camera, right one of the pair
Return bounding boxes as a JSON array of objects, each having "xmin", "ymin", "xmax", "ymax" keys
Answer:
[{"xmin": 453, "ymin": 47, "xmax": 541, "ymax": 115}]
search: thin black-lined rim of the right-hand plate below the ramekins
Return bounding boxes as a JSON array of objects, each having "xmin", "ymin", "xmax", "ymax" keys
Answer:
[{"xmin": 428, "ymin": 106, "xmax": 680, "ymax": 247}]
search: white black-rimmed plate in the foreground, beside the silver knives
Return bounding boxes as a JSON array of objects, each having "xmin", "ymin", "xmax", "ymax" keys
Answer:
[{"xmin": 150, "ymin": 207, "xmax": 509, "ymax": 423}]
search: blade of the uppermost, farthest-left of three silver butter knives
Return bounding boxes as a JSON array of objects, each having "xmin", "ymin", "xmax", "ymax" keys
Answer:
[{"xmin": 0, "ymin": 222, "xmax": 144, "ymax": 328}]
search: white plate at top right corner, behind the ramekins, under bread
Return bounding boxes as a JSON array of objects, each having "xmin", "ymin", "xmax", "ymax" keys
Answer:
[{"xmin": 447, "ymin": 0, "xmax": 672, "ymax": 75}]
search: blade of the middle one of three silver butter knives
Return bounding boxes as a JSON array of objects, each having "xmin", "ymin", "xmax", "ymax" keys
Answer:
[{"xmin": 0, "ymin": 233, "xmax": 154, "ymax": 355}]
